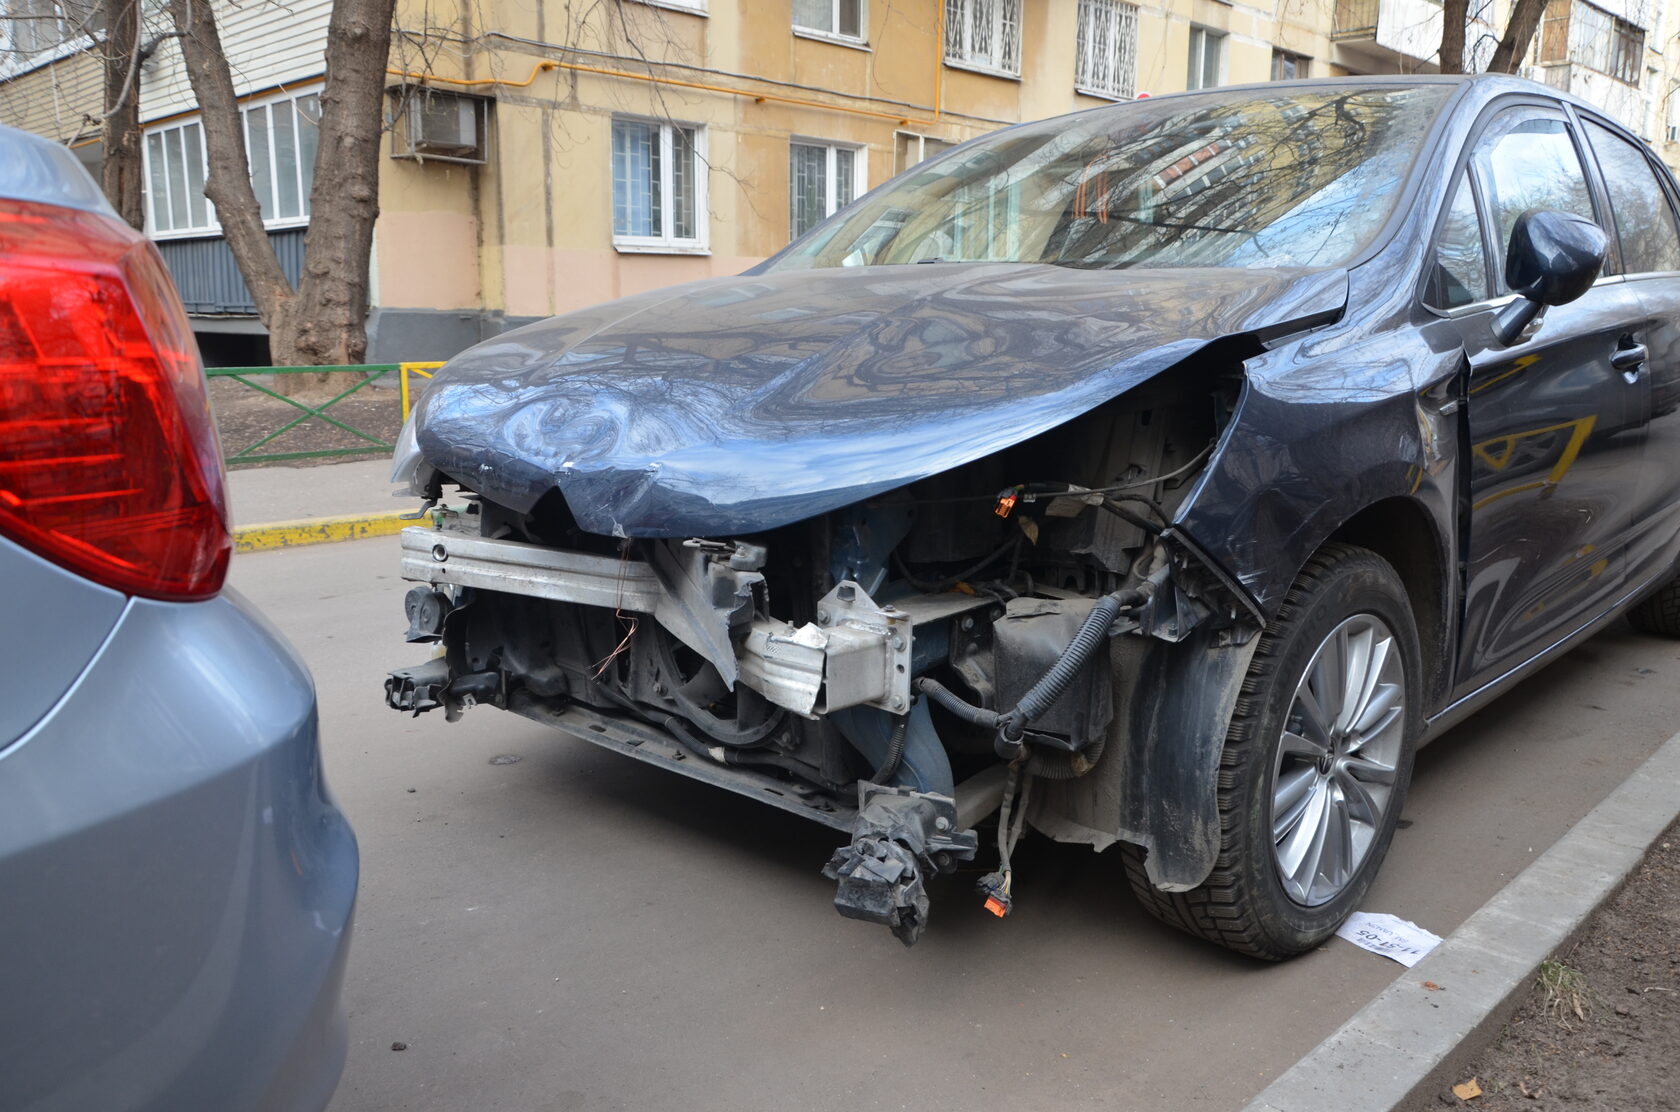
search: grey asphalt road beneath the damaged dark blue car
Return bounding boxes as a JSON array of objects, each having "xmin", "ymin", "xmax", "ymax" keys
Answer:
[{"xmin": 232, "ymin": 538, "xmax": 1680, "ymax": 1112}]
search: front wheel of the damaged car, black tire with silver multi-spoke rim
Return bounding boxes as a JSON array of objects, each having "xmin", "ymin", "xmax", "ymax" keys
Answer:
[{"xmin": 1122, "ymin": 544, "xmax": 1423, "ymax": 961}]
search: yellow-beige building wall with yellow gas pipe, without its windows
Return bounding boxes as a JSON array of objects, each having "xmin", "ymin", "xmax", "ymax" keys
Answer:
[{"xmin": 367, "ymin": 0, "xmax": 1350, "ymax": 342}]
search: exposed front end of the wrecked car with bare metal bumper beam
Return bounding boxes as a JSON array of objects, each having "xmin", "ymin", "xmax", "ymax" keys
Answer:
[{"xmin": 386, "ymin": 375, "xmax": 1260, "ymax": 944}]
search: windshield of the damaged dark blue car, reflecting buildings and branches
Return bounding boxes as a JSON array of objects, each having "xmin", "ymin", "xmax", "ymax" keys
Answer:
[{"xmin": 769, "ymin": 86, "xmax": 1452, "ymax": 270}]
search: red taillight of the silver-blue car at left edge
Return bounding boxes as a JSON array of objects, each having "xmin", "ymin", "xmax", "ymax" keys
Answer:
[{"xmin": 0, "ymin": 200, "xmax": 232, "ymax": 600}]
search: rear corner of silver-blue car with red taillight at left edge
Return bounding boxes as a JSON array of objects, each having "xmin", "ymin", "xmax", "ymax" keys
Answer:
[{"xmin": 0, "ymin": 128, "xmax": 358, "ymax": 1112}]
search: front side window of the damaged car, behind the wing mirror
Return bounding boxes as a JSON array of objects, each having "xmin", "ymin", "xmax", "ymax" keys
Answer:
[{"xmin": 1472, "ymin": 108, "xmax": 1598, "ymax": 284}]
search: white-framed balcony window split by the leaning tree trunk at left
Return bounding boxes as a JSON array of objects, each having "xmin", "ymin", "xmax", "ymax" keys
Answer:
[{"xmin": 143, "ymin": 92, "xmax": 321, "ymax": 239}]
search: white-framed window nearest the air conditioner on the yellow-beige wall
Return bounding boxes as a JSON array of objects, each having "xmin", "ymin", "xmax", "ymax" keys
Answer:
[{"xmin": 613, "ymin": 116, "xmax": 706, "ymax": 254}]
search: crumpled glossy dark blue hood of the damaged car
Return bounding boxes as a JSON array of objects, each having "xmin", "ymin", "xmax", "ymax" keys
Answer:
[{"xmin": 413, "ymin": 264, "xmax": 1347, "ymax": 538}]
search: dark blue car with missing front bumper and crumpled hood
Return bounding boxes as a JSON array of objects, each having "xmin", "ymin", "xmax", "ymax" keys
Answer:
[{"xmin": 386, "ymin": 77, "xmax": 1680, "ymax": 959}]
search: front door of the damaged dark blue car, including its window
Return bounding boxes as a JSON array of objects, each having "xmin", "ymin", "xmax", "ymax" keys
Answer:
[{"xmin": 1438, "ymin": 106, "xmax": 1650, "ymax": 694}]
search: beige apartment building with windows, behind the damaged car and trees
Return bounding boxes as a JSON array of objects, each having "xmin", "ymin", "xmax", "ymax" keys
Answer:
[{"xmin": 0, "ymin": 0, "xmax": 1680, "ymax": 363}]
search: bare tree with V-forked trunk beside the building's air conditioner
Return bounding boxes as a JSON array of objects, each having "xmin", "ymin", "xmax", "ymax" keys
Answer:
[{"xmin": 168, "ymin": 0, "xmax": 395, "ymax": 390}]
